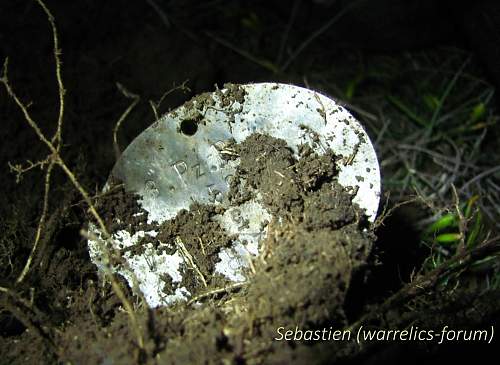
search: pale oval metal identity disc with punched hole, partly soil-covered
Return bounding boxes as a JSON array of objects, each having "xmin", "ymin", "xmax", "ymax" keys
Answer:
[{"xmin": 89, "ymin": 83, "xmax": 380, "ymax": 307}]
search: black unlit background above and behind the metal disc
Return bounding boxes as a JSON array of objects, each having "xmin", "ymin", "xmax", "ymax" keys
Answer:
[{"xmin": 0, "ymin": 0, "xmax": 500, "ymax": 207}]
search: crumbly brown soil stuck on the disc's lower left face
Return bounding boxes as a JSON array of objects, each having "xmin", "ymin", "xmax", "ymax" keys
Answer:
[{"xmin": 93, "ymin": 182, "xmax": 237, "ymax": 296}]
